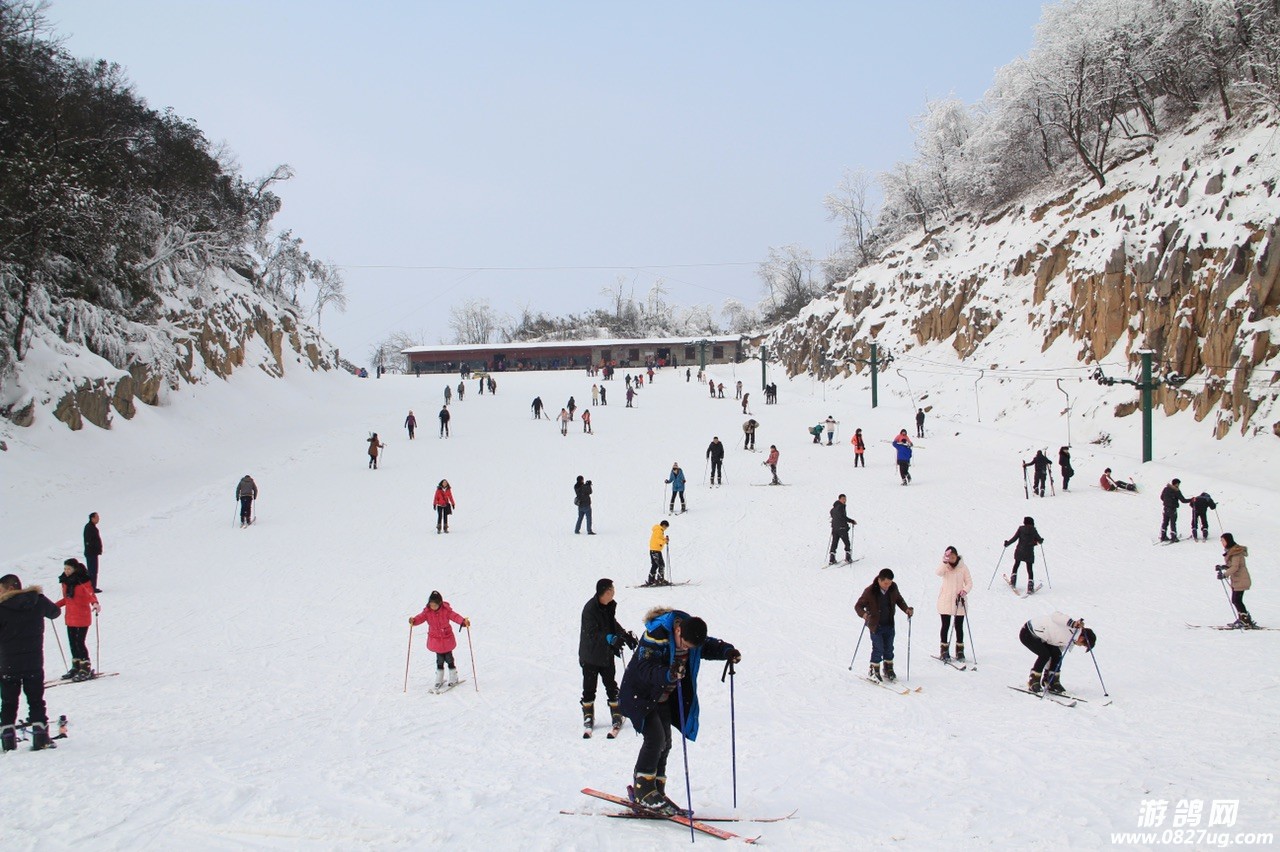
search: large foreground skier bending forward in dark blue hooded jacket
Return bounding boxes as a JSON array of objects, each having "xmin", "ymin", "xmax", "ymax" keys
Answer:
[{"xmin": 618, "ymin": 606, "xmax": 742, "ymax": 815}]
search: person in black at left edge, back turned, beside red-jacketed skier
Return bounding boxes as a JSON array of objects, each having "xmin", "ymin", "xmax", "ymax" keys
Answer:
[{"xmin": 0, "ymin": 574, "xmax": 61, "ymax": 751}]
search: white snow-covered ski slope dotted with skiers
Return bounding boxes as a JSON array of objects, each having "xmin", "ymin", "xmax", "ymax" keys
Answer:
[{"xmin": 0, "ymin": 366, "xmax": 1280, "ymax": 849}]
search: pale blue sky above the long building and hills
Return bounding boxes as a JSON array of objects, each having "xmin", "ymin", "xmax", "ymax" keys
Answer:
[{"xmin": 50, "ymin": 0, "xmax": 1041, "ymax": 363}]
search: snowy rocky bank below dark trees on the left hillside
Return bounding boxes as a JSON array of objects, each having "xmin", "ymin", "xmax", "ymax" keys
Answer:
[{"xmin": 0, "ymin": 270, "xmax": 338, "ymax": 430}]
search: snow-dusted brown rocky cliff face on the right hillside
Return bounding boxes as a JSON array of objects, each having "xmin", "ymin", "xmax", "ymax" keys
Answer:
[{"xmin": 771, "ymin": 114, "xmax": 1280, "ymax": 438}]
